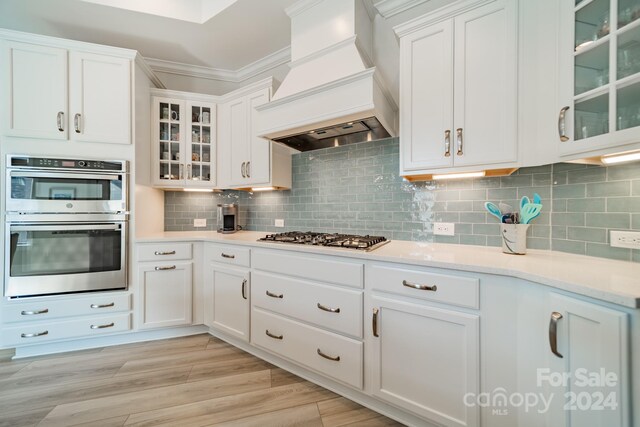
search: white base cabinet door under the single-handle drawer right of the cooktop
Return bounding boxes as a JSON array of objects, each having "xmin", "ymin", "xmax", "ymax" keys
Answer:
[{"xmin": 365, "ymin": 296, "xmax": 480, "ymax": 426}]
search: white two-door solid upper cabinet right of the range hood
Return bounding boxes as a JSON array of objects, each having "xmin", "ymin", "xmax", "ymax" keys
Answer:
[{"xmin": 394, "ymin": 0, "xmax": 518, "ymax": 176}]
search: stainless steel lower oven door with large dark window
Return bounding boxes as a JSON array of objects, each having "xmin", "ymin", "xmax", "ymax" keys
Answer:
[{"xmin": 5, "ymin": 222, "xmax": 127, "ymax": 297}]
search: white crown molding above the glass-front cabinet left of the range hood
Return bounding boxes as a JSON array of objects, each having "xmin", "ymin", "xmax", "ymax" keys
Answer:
[{"xmin": 145, "ymin": 46, "xmax": 291, "ymax": 83}]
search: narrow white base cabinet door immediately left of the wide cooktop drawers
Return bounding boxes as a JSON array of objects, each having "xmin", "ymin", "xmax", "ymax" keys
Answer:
[{"xmin": 204, "ymin": 262, "xmax": 250, "ymax": 342}]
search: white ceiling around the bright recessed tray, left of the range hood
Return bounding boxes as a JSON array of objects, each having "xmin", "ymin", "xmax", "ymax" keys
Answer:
[{"xmin": 0, "ymin": 0, "xmax": 295, "ymax": 70}]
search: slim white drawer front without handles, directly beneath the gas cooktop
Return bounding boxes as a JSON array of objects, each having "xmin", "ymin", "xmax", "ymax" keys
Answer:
[{"xmin": 253, "ymin": 250, "xmax": 364, "ymax": 288}]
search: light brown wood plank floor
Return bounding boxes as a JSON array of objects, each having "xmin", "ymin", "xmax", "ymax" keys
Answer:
[{"xmin": 0, "ymin": 334, "xmax": 401, "ymax": 427}]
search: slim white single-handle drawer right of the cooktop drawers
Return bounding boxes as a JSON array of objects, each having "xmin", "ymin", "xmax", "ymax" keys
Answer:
[{"xmin": 367, "ymin": 264, "xmax": 480, "ymax": 309}]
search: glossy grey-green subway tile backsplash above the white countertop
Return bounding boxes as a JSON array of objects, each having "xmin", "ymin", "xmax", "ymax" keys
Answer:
[{"xmin": 165, "ymin": 138, "xmax": 640, "ymax": 262}]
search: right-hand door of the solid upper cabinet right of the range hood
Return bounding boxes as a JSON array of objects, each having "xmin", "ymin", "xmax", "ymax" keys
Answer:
[{"xmin": 451, "ymin": 0, "xmax": 518, "ymax": 167}]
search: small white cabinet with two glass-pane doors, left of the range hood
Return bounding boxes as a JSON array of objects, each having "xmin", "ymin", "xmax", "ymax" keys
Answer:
[{"xmin": 152, "ymin": 93, "xmax": 216, "ymax": 188}]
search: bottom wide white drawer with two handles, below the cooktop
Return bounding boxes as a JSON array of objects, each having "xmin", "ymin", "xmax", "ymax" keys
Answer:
[{"xmin": 251, "ymin": 308, "xmax": 363, "ymax": 389}]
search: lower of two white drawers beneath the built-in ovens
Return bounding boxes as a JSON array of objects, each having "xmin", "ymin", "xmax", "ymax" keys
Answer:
[{"xmin": 2, "ymin": 313, "xmax": 131, "ymax": 347}]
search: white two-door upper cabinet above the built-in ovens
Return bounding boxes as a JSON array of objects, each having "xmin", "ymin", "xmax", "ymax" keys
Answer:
[{"xmin": 1, "ymin": 37, "xmax": 135, "ymax": 144}]
